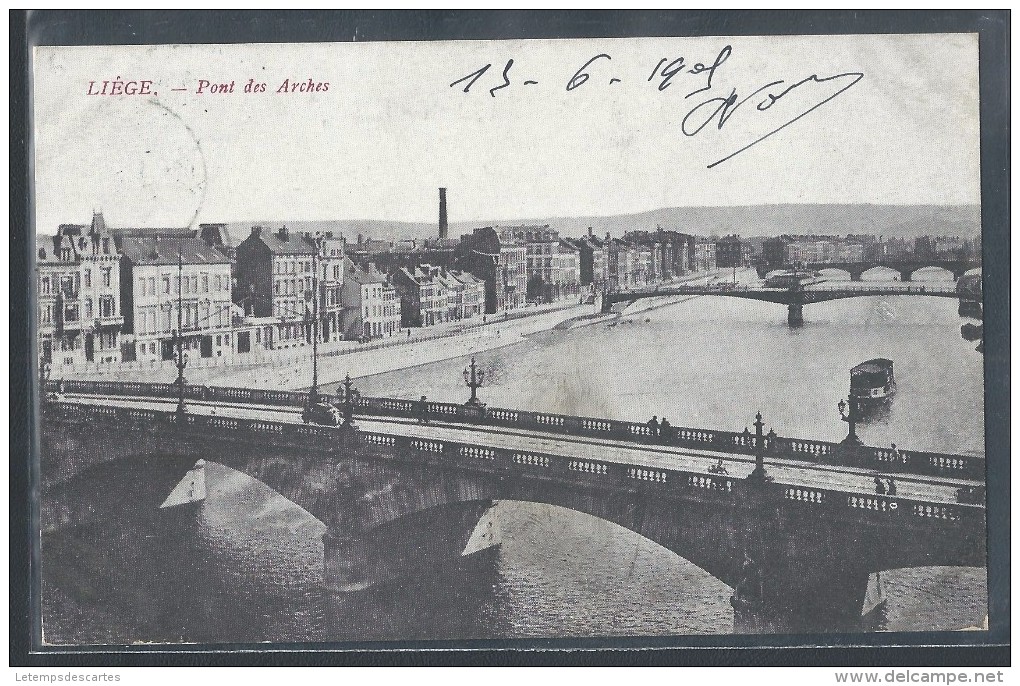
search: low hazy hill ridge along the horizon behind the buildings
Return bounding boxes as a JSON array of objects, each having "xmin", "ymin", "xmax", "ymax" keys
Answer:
[{"xmin": 228, "ymin": 205, "xmax": 981, "ymax": 242}]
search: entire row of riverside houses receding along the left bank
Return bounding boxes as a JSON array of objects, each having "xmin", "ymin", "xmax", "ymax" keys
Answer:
[{"xmin": 37, "ymin": 212, "xmax": 734, "ymax": 364}]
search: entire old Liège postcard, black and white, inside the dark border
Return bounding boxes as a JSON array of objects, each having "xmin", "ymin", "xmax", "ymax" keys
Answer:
[{"xmin": 30, "ymin": 20, "xmax": 1008, "ymax": 647}]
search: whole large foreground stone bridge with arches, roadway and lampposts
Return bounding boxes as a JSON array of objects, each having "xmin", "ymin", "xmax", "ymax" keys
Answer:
[{"xmin": 42, "ymin": 381, "xmax": 985, "ymax": 631}]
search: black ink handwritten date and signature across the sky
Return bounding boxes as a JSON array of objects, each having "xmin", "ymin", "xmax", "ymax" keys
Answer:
[{"xmin": 450, "ymin": 45, "xmax": 864, "ymax": 169}]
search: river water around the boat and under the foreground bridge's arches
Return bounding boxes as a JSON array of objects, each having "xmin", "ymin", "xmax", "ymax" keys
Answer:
[{"xmin": 43, "ymin": 272, "xmax": 986, "ymax": 643}]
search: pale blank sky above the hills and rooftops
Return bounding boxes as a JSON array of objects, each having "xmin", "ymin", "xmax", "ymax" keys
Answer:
[{"xmin": 33, "ymin": 34, "xmax": 980, "ymax": 233}]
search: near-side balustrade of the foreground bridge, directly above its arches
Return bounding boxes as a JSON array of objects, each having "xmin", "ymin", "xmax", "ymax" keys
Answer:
[{"xmin": 43, "ymin": 402, "xmax": 984, "ymax": 527}]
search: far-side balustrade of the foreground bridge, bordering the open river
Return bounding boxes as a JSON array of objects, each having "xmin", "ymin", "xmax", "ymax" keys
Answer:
[{"xmin": 47, "ymin": 380, "xmax": 985, "ymax": 480}]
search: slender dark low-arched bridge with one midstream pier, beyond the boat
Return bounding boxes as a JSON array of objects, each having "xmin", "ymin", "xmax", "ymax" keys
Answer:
[{"xmin": 602, "ymin": 281, "xmax": 972, "ymax": 326}]
